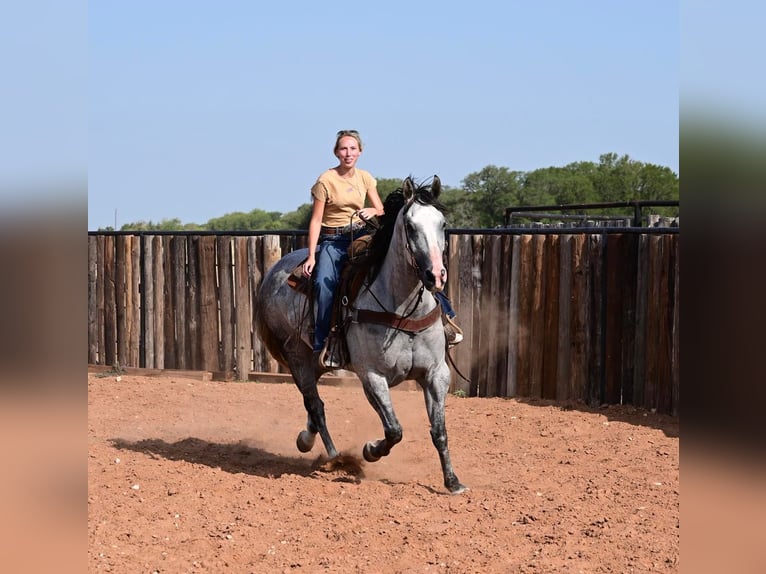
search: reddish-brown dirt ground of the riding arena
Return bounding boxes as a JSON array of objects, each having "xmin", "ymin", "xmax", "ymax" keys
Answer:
[{"xmin": 88, "ymin": 373, "xmax": 680, "ymax": 574}]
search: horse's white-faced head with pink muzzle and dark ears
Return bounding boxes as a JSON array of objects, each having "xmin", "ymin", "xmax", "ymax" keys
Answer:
[{"xmin": 402, "ymin": 175, "xmax": 447, "ymax": 291}]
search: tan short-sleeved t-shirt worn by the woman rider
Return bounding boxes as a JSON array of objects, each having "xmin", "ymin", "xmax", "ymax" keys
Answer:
[{"xmin": 311, "ymin": 167, "xmax": 377, "ymax": 227}]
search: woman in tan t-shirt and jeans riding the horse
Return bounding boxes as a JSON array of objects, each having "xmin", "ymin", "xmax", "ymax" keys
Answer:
[{"xmin": 303, "ymin": 130, "xmax": 463, "ymax": 369}]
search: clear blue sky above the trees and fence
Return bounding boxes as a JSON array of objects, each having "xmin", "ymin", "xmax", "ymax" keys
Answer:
[{"xmin": 88, "ymin": 0, "xmax": 679, "ymax": 229}]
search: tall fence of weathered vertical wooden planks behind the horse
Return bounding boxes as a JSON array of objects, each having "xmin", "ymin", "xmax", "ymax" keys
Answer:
[{"xmin": 88, "ymin": 229, "xmax": 679, "ymax": 415}]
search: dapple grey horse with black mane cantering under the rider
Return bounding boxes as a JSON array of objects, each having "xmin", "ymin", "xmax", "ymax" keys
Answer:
[{"xmin": 256, "ymin": 176, "xmax": 466, "ymax": 493}]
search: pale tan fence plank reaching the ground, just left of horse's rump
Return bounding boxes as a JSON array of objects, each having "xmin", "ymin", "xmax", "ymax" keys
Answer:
[{"xmin": 234, "ymin": 237, "xmax": 253, "ymax": 380}]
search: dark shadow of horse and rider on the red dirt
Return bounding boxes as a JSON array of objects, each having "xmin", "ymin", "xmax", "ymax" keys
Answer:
[{"xmin": 110, "ymin": 437, "xmax": 326, "ymax": 478}]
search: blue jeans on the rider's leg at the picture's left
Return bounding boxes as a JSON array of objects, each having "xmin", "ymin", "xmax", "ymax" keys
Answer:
[{"xmin": 311, "ymin": 234, "xmax": 360, "ymax": 351}]
